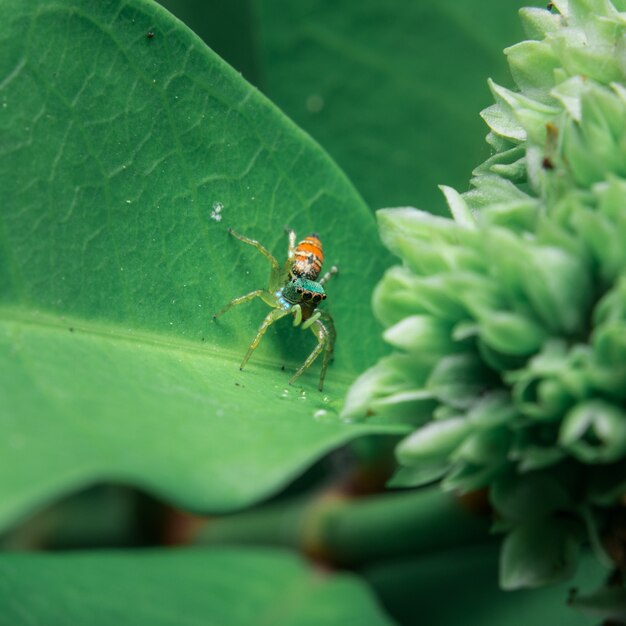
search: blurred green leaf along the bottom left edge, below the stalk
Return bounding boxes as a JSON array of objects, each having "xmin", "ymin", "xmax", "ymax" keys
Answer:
[{"xmin": 0, "ymin": 549, "xmax": 392, "ymax": 626}]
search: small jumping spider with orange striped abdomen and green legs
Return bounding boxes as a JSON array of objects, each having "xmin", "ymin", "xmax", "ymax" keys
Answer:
[{"xmin": 213, "ymin": 228, "xmax": 337, "ymax": 391}]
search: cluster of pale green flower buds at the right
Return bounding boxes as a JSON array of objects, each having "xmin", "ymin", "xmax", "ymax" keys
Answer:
[{"xmin": 345, "ymin": 1, "xmax": 626, "ymax": 617}]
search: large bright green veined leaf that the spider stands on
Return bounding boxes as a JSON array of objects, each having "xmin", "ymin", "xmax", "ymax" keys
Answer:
[{"xmin": 0, "ymin": 0, "xmax": 404, "ymax": 526}]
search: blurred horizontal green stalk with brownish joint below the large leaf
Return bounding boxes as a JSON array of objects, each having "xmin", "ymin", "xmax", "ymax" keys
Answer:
[{"xmin": 197, "ymin": 488, "xmax": 489, "ymax": 566}]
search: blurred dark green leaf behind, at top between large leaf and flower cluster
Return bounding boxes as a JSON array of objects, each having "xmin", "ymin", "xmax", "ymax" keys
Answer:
[{"xmin": 163, "ymin": 0, "xmax": 527, "ymax": 215}]
